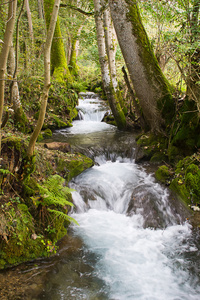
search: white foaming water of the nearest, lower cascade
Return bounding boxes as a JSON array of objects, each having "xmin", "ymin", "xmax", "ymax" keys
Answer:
[{"xmin": 71, "ymin": 161, "xmax": 200, "ymax": 300}]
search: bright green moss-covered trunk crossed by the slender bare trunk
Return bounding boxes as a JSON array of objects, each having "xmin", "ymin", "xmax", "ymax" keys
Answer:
[{"xmin": 44, "ymin": 0, "xmax": 72, "ymax": 82}]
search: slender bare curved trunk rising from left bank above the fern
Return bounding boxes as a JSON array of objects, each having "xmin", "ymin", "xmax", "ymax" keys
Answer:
[{"xmin": 27, "ymin": 0, "xmax": 60, "ymax": 158}]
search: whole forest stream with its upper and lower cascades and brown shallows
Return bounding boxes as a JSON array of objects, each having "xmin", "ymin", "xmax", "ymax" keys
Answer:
[{"xmin": 1, "ymin": 93, "xmax": 200, "ymax": 300}]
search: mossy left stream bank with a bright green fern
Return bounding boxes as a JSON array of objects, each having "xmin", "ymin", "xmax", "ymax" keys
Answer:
[{"xmin": 0, "ymin": 134, "xmax": 93, "ymax": 268}]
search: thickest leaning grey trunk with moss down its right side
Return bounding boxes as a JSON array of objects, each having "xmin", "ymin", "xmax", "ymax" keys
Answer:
[{"xmin": 109, "ymin": 0, "xmax": 174, "ymax": 132}]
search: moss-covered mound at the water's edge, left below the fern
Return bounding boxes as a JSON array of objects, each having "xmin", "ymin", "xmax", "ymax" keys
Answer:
[{"xmin": 0, "ymin": 203, "xmax": 48, "ymax": 268}]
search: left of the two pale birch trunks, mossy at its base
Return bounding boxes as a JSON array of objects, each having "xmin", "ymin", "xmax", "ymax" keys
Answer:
[{"xmin": 94, "ymin": 0, "xmax": 126, "ymax": 130}]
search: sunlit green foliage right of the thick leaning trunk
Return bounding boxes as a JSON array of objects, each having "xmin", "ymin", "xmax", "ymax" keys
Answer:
[{"xmin": 139, "ymin": 0, "xmax": 200, "ymax": 94}]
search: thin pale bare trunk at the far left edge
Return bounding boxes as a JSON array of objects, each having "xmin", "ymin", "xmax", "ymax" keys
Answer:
[{"xmin": 0, "ymin": 0, "xmax": 17, "ymax": 152}]
